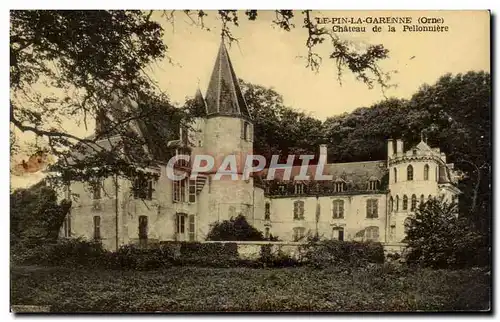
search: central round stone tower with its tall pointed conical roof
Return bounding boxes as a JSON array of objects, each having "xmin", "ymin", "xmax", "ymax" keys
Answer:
[{"xmin": 204, "ymin": 42, "xmax": 254, "ymax": 223}]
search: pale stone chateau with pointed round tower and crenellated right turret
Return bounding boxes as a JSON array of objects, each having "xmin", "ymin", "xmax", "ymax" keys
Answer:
[{"xmin": 61, "ymin": 43, "xmax": 460, "ymax": 249}]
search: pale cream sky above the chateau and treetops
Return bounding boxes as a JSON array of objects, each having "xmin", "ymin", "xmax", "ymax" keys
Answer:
[{"xmin": 9, "ymin": 11, "xmax": 490, "ymax": 189}]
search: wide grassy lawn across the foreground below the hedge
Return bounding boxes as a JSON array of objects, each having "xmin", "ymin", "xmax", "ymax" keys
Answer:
[{"xmin": 11, "ymin": 266, "xmax": 491, "ymax": 312}]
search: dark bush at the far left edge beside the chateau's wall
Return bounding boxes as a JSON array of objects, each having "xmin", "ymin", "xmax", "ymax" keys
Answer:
[{"xmin": 10, "ymin": 182, "xmax": 71, "ymax": 244}]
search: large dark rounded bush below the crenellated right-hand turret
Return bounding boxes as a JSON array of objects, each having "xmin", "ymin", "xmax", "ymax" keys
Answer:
[{"xmin": 406, "ymin": 199, "xmax": 489, "ymax": 268}]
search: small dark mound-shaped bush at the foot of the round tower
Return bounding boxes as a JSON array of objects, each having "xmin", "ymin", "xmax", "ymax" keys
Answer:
[{"xmin": 207, "ymin": 215, "xmax": 265, "ymax": 241}]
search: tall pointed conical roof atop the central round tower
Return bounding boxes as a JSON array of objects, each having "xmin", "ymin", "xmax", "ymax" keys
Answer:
[{"xmin": 205, "ymin": 41, "xmax": 251, "ymax": 118}]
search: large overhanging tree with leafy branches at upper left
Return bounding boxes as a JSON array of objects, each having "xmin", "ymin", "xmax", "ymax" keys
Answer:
[{"xmin": 10, "ymin": 10, "xmax": 388, "ymax": 186}]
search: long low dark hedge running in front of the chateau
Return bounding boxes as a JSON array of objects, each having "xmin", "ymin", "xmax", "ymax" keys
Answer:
[{"xmin": 13, "ymin": 239, "xmax": 384, "ymax": 270}]
